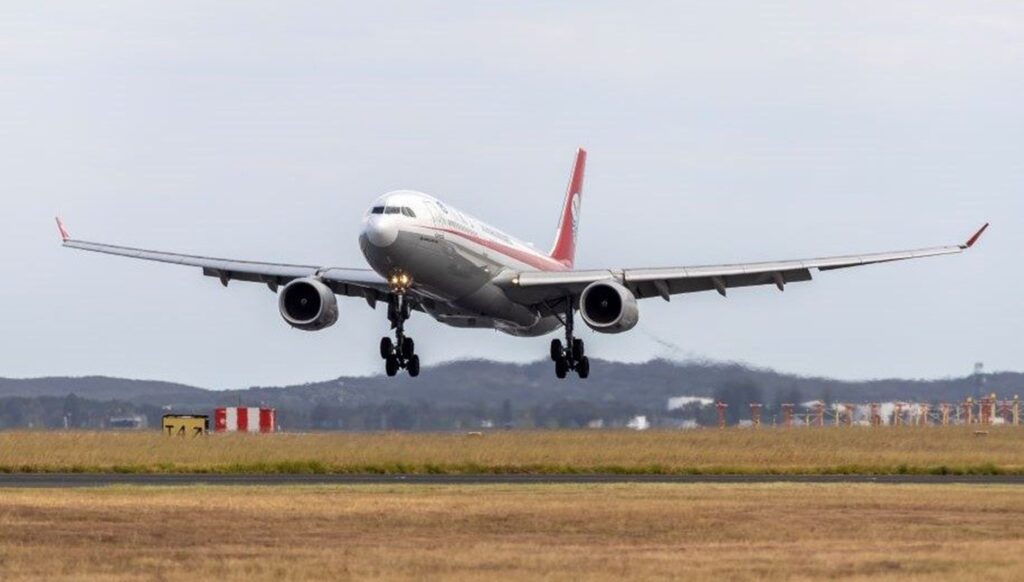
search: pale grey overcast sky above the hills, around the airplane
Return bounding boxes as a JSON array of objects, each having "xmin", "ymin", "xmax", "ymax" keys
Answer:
[{"xmin": 0, "ymin": 0, "xmax": 1024, "ymax": 388}]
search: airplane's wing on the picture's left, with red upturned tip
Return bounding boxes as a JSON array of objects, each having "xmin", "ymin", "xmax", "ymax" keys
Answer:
[{"xmin": 57, "ymin": 218, "xmax": 387, "ymax": 303}]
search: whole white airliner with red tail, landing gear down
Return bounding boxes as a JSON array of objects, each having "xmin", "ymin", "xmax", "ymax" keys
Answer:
[{"xmin": 57, "ymin": 148, "xmax": 988, "ymax": 379}]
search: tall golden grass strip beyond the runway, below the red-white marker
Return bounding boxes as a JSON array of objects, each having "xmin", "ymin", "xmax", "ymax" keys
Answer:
[{"xmin": 0, "ymin": 427, "xmax": 1024, "ymax": 474}]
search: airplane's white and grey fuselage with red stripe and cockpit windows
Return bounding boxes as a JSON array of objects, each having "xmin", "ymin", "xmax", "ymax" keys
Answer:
[{"xmin": 359, "ymin": 191, "xmax": 568, "ymax": 336}]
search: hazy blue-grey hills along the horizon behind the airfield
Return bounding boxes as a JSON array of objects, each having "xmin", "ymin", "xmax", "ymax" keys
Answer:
[{"xmin": 0, "ymin": 360, "xmax": 1024, "ymax": 412}]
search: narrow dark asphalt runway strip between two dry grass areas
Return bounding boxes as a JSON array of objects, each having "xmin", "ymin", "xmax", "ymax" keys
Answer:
[{"xmin": 0, "ymin": 473, "xmax": 1024, "ymax": 489}]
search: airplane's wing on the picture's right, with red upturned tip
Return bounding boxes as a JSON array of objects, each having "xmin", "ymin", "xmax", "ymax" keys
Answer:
[{"xmin": 498, "ymin": 223, "xmax": 988, "ymax": 305}]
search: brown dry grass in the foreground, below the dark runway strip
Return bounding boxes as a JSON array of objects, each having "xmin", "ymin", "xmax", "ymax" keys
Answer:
[{"xmin": 0, "ymin": 485, "xmax": 1024, "ymax": 581}]
